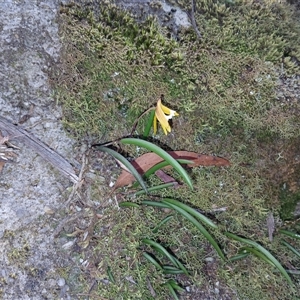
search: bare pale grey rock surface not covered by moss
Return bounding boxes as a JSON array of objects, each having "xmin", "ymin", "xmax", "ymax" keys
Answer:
[{"xmin": 0, "ymin": 0, "xmax": 300, "ymax": 300}]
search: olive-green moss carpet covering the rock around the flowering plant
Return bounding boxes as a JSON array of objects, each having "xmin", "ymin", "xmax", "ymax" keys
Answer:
[{"xmin": 56, "ymin": 0, "xmax": 300, "ymax": 299}]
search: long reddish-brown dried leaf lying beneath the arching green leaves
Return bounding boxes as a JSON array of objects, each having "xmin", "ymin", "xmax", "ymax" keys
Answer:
[{"xmin": 114, "ymin": 151, "xmax": 230, "ymax": 188}]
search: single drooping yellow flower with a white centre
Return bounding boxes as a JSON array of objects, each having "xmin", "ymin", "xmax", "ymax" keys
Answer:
[{"xmin": 153, "ymin": 99, "xmax": 179, "ymax": 134}]
